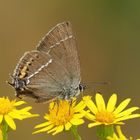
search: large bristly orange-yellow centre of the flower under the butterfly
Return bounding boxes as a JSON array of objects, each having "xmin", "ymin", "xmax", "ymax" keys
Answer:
[{"xmin": 49, "ymin": 100, "xmax": 74, "ymax": 125}]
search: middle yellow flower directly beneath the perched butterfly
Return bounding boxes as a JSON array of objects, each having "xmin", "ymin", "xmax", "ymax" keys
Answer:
[{"xmin": 33, "ymin": 99, "xmax": 86, "ymax": 135}]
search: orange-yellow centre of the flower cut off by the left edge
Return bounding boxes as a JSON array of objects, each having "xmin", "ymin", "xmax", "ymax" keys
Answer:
[{"xmin": 0, "ymin": 98, "xmax": 15, "ymax": 115}]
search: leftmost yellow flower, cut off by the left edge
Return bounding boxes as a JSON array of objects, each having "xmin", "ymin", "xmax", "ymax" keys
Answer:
[{"xmin": 0, "ymin": 97, "xmax": 38, "ymax": 130}]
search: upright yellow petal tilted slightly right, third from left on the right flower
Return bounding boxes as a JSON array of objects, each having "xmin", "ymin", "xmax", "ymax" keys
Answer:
[{"xmin": 107, "ymin": 94, "xmax": 117, "ymax": 112}]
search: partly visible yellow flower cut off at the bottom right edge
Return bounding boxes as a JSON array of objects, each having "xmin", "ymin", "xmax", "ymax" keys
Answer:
[{"xmin": 107, "ymin": 125, "xmax": 139, "ymax": 140}]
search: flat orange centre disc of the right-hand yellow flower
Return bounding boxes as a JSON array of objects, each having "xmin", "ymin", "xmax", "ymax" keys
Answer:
[{"xmin": 96, "ymin": 111, "xmax": 115, "ymax": 123}]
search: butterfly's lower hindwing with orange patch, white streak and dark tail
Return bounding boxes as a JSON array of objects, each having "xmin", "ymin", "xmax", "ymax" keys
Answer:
[{"xmin": 12, "ymin": 50, "xmax": 61, "ymax": 100}]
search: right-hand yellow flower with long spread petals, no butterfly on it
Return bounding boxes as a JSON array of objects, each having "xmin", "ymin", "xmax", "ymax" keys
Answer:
[{"xmin": 83, "ymin": 93, "xmax": 140, "ymax": 128}]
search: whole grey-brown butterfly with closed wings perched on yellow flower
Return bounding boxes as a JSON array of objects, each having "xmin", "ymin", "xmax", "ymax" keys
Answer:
[{"xmin": 9, "ymin": 22, "xmax": 83, "ymax": 102}]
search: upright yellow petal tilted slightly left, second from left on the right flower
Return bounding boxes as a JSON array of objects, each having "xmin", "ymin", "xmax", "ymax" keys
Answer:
[{"xmin": 95, "ymin": 93, "xmax": 105, "ymax": 112}]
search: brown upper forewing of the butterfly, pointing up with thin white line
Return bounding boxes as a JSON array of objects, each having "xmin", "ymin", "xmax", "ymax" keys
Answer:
[{"xmin": 37, "ymin": 22, "xmax": 81, "ymax": 88}]
